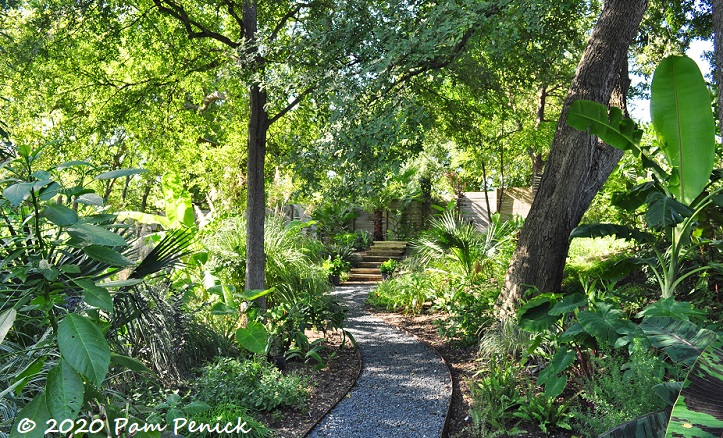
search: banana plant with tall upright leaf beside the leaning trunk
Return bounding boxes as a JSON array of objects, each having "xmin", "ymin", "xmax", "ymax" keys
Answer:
[{"xmin": 567, "ymin": 56, "xmax": 723, "ymax": 299}]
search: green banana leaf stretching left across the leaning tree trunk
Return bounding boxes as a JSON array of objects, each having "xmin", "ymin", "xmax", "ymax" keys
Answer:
[{"xmin": 567, "ymin": 100, "xmax": 643, "ymax": 151}]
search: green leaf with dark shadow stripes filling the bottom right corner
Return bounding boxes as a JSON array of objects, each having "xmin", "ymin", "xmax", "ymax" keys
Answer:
[{"xmin": 665, "ymin": 342, "xmax": 723, "ymax": 438}]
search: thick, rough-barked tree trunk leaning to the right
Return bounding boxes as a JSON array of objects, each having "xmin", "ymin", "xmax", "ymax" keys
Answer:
[{"xmin": 498, "ymin": 0, "xmax": 647, "ymax": 317}]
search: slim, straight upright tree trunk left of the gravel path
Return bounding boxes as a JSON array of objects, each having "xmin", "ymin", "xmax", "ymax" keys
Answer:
[{"xmin": 243, "ymin": 0, "xmax": 269, "ymax": 308}]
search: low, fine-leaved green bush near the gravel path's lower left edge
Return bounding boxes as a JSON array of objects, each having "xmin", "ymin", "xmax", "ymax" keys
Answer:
[{"xmin": 192, "ymin": 357, "xmax": 309, "ymax": 411}]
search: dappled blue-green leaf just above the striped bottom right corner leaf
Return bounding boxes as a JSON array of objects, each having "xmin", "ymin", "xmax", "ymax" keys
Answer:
[{"xmin": 640, "ymin": 316, "xmax": 717, "ymax": 365}]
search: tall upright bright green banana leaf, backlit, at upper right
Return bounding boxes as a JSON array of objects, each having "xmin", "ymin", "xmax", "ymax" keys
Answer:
[{"xmin": 650, "ymin": 56, "xmax": 715, "ymax": 204}]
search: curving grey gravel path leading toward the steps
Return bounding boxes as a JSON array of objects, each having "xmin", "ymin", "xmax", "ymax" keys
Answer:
[{"xmin": 307, "ymin": 286, "xmax": 452, "ymax": 438}]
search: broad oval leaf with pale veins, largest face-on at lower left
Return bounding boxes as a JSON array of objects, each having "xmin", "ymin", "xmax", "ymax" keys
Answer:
[{"xmin": 58, "ymin": 313, "xmax": 110, "ymax": 385}]
